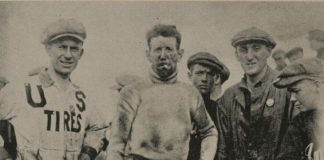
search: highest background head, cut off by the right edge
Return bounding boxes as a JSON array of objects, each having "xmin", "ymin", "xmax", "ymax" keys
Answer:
[{"xmin": 308, "ymin": 29, "xmax": 324, "ymax": 60}]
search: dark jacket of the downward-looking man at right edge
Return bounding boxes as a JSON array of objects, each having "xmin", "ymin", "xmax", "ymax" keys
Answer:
[{"xmin": 278, "ymin": 110, "xmax": 318, "ymax": 160}]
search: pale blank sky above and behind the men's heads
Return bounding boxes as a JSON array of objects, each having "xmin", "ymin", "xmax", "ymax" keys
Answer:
[{"xmin": 0, "ymin": 2, "xmax": 324, "ymax": 121}]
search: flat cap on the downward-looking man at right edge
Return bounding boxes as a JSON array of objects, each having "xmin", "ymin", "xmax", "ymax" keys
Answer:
[{"xmin": 274, "ymin": 58, "xmax": 324, "ymax": 88}]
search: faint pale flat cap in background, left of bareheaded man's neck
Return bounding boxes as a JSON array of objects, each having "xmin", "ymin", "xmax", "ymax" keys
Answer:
[{"xmin": 110, "ymin": 74, "xmax": 142, "ymax": 90}]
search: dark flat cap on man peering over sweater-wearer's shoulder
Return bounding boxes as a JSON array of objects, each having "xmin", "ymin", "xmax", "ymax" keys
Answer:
[{"xmin": 187, "ymin": 52, "xmax": 230, "ymax": 83}]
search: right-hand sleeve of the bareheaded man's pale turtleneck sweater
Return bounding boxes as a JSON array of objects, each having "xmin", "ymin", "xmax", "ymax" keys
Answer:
[{"xmin": 193, "ymin": 90, "xmax": 218, "ymax": 160}]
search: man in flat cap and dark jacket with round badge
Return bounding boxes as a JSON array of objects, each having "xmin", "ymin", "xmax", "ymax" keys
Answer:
[{"xmin": 216, "ymin": 27, "xmax": 290, "ymax": 160}]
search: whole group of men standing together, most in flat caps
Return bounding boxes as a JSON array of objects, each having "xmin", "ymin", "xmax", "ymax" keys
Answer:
[{"xmin": 0, "ymin": 19, "xmax": 324, "ymax": 160}]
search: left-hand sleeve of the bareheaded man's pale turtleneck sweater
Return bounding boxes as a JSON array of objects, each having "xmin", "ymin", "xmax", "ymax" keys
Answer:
[{"xmin": 107, "ymin": 87, "xmax": 139, "ymax": 160}]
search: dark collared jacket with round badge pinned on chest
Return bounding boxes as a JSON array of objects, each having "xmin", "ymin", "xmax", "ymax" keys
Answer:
[{"xmin": 217, "ymin": 67, "xmax": 290, "ymax": 160}]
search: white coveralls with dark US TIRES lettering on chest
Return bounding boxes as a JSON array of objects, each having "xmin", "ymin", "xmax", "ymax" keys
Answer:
[{"xmin": 0, "ymin": 75, "xmax": 105, "ymax": 160}]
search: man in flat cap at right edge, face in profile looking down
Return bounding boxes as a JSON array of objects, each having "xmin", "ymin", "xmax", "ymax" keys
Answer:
[{"xmin": 274, "ymin": 58, "xmax": 324, "ymax": 160}]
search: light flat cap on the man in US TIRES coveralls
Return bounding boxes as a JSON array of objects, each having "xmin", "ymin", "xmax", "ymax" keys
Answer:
[{"xmin": 41, "ymin": 19, "xmax": 87, "ymax": 44}]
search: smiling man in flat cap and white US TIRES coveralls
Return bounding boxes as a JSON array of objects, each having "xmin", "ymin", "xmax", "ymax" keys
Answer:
[{"xmin": 0, "ymin": 19, "xmax": 105, "ymax": 160}]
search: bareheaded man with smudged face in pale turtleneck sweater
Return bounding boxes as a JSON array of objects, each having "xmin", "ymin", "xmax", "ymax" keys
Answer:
[{"xmin": 108, "ymin": 24, "xmax": 217, "ymax": 160}]
